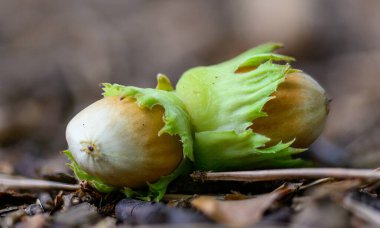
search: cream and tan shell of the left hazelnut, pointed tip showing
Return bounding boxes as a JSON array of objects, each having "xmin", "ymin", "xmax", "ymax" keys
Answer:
[{"xmin": 66, "ymin": 97, "xmax": 183, "ymax": 188}]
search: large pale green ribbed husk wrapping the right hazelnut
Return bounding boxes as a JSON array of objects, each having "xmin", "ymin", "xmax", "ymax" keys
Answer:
[{"xmin": 176, "ymin": 43, "xmax": 314, "ymax": 171}]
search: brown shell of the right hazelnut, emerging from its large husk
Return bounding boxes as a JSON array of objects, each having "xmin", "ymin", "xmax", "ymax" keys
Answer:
[{"xmin": 251, "ymin": 72, "xmax": 329, "ymax": 148}]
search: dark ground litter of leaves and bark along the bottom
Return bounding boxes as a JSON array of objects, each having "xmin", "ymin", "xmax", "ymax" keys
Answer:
[{"xmin": 0, "ymin": 170, "xmax": 380, "ymax": 227}]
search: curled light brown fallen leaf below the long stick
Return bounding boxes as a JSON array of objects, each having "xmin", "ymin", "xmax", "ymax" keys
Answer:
[{"xmin": 191, "ymin": 184, "xmax": 299, "ymax": 227}]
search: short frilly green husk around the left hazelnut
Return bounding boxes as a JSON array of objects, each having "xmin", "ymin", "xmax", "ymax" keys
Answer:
[{"xmin": 64, "ymin": 75, "xmax": 194, "ymax": 201}]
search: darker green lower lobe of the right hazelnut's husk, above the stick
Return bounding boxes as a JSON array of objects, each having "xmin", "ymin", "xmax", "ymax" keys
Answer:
[{"xmin": 194, "ymin": 130, "xmax": 310, "ymax": 171}]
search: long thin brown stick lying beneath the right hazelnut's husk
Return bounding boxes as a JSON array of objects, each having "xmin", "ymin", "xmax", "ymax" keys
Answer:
[{"xmin": 191, "ymin": 168, "xmax": 380, "ymax": 182}]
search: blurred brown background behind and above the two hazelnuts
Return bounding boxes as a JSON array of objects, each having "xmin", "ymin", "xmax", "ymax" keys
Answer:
[{"xmin": 0, "ymin": 0, "xmax": 380, "ymax": 177}]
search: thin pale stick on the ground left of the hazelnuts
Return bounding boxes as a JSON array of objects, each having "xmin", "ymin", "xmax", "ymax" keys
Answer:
[{"xmin": 0, "ymin": 177, "xmax": 80, "ymax": 191}]
